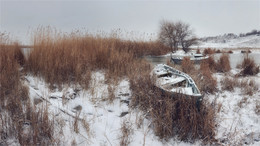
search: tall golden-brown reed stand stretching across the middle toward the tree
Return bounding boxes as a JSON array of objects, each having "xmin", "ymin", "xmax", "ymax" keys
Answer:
[{"xmin": 27, "ymin": 27, "xmax": 167, "ymax": 87}]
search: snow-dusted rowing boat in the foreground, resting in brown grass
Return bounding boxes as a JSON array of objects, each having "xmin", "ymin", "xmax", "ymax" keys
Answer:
[{"xmin": 151, "ymin": 64, "xmax": 202, "ymax": 98}]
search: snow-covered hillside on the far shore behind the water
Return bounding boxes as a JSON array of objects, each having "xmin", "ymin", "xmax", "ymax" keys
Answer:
[{"xmin": 197, "ymin": 35, "xmax": 260, "ymax": 48}]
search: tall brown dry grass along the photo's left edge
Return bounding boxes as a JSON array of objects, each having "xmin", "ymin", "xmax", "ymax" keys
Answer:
[{"xmin": 0, "ymin": 36, "xmax": 55, "ymax": 145}]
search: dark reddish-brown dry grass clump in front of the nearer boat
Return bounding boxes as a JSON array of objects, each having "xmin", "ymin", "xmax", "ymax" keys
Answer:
[{"xmin": 130, "ymin": 73, "xmax": 215, "ymax": 142}]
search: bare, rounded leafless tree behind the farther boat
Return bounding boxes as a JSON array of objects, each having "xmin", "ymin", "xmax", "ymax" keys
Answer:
[{"xmin": 159, "ymin": 20, "xmax": 197, "ymax": 52}]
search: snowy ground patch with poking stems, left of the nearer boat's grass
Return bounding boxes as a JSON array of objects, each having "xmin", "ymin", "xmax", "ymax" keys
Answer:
[{"xmin": 24, "ymin": 72, "xmax": 199, "ymax": 146}]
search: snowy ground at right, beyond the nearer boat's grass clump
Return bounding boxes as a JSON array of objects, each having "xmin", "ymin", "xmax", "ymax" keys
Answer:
[{"xmin": 209, "ymin": 69, "xmax": 260, "ymax": 145}]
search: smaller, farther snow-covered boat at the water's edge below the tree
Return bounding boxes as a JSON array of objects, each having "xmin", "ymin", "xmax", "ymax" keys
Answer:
[{"xmin": 171, "ymin": 53, "xmax": 209, "ymax": 64}]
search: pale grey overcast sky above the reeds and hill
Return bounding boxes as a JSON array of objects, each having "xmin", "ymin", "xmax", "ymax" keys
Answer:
[{"xmin": 0, "ymin": 0, "xmax": 260, "ymax": 44}]
